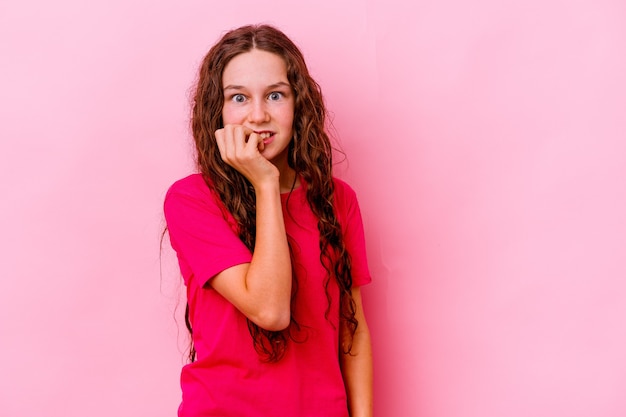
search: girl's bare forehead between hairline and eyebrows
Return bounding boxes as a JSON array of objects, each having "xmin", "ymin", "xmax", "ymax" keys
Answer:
[{"xmin": 222, "ymin": 49, "xmax": 288, "ymax": 87}]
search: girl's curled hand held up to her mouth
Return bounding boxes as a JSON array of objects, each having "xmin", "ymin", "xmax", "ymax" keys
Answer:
[{"xmin": 215, "ymin": 125, "xmax": 280, "ymax": 188}]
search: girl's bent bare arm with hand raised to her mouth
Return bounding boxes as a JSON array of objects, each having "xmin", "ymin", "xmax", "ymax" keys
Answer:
[{"xmin": 209, "ymin": 126, "xmax": 292, "ymax": 330}]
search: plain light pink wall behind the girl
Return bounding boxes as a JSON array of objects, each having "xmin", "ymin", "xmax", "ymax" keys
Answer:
[{"xmin": 0, "ymin": 0, "xmax": 626, "ymax": 417}]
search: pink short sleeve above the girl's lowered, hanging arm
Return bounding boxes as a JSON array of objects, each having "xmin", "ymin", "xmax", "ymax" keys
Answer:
[{"xmin": 335, "ymin": 179, "xmax": 372, "ymax": 287}]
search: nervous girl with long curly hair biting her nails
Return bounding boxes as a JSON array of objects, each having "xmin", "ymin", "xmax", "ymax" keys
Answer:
[{"xmin": 164, "ymin": 25, "xmax": 372, "ymax": 417}]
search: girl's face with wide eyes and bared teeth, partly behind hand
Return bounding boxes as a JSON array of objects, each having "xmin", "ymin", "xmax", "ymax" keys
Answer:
[{"xmin": 222, "ymin": 49, "xmax": 294, "ymax": 169}]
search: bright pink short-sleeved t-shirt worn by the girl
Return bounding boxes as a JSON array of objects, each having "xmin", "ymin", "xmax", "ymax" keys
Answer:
[{"xmin": 164, "ymin": 174, "xmax": 371, "ymax": 417}]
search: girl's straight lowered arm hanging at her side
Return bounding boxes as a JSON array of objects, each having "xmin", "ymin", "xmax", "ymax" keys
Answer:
[{"xmin": 340, "ymin": 287, "xmax": 373, "ymax": 417}]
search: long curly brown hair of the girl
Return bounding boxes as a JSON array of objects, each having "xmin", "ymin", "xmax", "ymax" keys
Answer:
[{"xmin": 185, "ymin": 25, "xmax": 358, "ymax": 362}]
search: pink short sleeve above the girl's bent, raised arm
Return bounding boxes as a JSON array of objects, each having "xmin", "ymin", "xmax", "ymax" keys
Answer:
[{"xmin": 163, "ymin": 175, "xmax": 252, "ymax": 286}]
